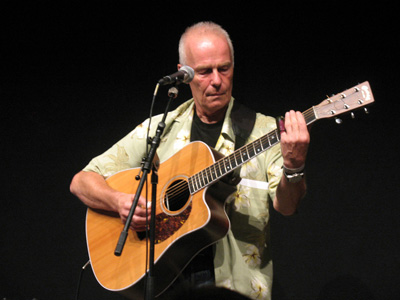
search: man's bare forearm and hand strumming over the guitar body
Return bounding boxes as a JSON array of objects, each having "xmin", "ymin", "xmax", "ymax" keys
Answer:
[{"xmin": 70, "ymin": 171, "xmax": 150, "ymax": 231}]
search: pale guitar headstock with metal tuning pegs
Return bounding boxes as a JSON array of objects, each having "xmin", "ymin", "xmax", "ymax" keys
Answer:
[{"xmin": 313, "ymin": 81, "xmax": 375, "ymax": 119}]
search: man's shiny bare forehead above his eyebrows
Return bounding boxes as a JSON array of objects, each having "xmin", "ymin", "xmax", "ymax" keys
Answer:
[{"xmin": 186, "ymin": 34, "xmax": 232, "ymax": 67}]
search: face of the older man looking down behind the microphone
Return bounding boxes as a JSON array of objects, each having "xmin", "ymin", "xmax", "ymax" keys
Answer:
[{"xmin": 179, "ymin": 34, "xmax": 233, "ymax": 120}]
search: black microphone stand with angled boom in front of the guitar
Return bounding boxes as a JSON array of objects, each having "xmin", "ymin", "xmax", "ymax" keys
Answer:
[{"xmin": 114, "ymin": 80, "xmax": 180, "ymax": 300}]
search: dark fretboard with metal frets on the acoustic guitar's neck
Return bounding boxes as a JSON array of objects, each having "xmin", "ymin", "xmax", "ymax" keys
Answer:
[{"xmin": 188, "ymin": 108, "xmax": 316, "ymax": 194}]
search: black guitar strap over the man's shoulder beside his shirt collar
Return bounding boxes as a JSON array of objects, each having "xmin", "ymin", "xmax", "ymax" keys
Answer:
[{"xmin": 231, "ymin": 100, "xmax": 256, "ymax": 150}]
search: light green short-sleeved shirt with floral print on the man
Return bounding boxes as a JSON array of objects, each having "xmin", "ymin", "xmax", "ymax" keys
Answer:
[{"xmin": 84, "ymin": 99, "xmax": 283, "ymax": 299}]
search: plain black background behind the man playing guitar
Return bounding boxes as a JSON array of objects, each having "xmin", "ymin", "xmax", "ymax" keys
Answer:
[{"xmin": 0, "ymin": 1, "xmax": 400, "ymax": 300}]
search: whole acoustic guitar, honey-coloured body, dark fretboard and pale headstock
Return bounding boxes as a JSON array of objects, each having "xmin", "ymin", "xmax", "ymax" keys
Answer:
[{"xmin": 86, "ymin": 81, "xmax": 374, "ymax": 299}]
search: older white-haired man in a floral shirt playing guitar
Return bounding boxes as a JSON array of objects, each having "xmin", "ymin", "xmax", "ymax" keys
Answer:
[{"xmin": 71, "ymin": 22, "xmax": 310, "ymax": 299}]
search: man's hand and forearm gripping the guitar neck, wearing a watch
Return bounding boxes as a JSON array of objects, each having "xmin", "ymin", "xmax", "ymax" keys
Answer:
[{"xmin": 273, "ymin": 111, "xmax": 310, "ymax": 215}]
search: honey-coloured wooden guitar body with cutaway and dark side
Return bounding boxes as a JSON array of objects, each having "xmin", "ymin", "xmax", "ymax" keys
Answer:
[{"xmin": 86, "ymin": 142, "xmax": 234, "ymax": 299}]
